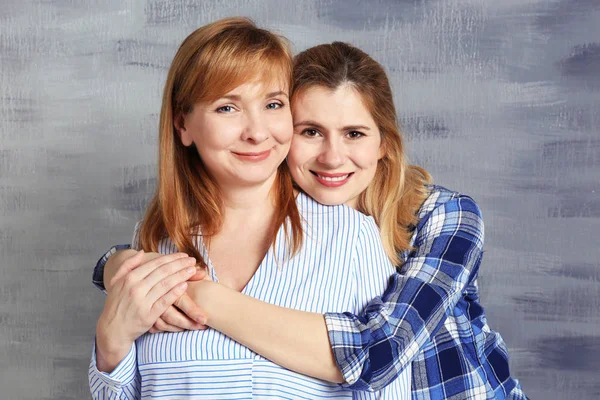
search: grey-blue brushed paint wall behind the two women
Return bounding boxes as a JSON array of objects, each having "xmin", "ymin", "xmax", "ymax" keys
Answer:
[{"xmin": 0, "ymin": 0, "xmax": 600, "ymax": 400}]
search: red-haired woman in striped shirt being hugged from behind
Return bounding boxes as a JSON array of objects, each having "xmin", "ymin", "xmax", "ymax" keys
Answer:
[{"xmin": 88, "ymin": 18, "xmax": 410, "ymax": 400}]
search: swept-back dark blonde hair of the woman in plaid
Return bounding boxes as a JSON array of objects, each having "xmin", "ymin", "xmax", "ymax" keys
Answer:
[{"xmin": 292, "ymin": 42, "xmax": 431, "ymax": 265}]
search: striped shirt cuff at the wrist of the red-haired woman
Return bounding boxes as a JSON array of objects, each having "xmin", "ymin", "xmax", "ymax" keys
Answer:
[{"xmin": 88, "ymin": 343, "xmax": 141, "ymax": 400}]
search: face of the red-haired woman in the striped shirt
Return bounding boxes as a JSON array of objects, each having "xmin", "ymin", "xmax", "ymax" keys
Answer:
[{"xmin": 177, "ymin": 82, "xmax": 293, "ymax": 189}]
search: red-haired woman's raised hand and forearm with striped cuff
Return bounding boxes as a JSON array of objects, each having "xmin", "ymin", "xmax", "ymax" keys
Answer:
[{"xmin": 88, "ymin": 251, "xmax": 196, "ymax": 399}]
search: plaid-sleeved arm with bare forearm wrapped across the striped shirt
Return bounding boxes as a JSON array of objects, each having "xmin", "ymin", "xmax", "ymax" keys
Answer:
[{"xmin": 185, "ymin": 196, "xmax": 483, "ymax": 390}]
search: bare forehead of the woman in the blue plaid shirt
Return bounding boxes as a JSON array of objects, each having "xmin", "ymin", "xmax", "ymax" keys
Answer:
[{"xmin": 292, "ymin": 85, "xmax": 376, "ymax": 129}]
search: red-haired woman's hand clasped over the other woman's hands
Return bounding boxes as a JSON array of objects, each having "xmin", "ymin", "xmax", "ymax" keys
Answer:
[{"xmin": 96, "ymin": 251, "xmax": 196, "ymax": 368}]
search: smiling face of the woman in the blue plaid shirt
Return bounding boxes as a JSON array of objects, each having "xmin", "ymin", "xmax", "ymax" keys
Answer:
[{"xmin": 287, "ymin": 85, "xmax": 383, "ymax": 208}]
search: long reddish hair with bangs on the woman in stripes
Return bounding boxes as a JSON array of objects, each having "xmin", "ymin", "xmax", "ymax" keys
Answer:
[{"xmin": 140, "ymin": 18, "xmax": 302, "ymax": 266}]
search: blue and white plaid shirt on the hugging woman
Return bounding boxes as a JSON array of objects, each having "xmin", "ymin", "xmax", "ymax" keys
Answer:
[{"xmin": 93, "ymin": 186, "xmax": 527, "ymax": 400}]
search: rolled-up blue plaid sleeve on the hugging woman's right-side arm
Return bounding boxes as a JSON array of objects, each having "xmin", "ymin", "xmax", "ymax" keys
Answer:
[{"xmin": 325, "ymin": 195, "xmax": 483, "ymax": 391}]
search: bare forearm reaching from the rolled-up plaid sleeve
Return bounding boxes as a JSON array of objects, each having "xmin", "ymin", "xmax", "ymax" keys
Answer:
[{"xmin": 199, "ymin": 282, "xmax": 344, "ymax": 383}]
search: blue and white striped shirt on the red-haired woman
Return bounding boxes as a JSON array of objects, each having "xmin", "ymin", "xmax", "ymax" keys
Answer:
[{"xmin": 89, "ymin": 193, "xmax": 411, "ymax": 400}]
